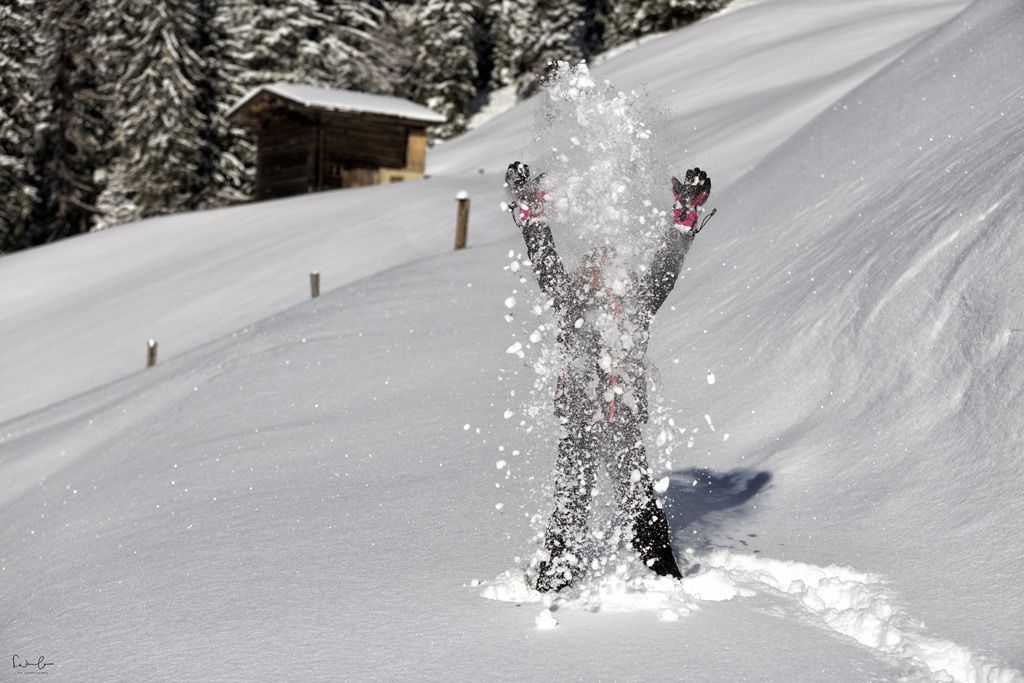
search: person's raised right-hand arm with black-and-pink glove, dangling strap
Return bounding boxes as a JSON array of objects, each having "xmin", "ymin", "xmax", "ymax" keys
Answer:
[{"xmin": 640, "ymin": 168, "xmax": 711, "ymax": 315}]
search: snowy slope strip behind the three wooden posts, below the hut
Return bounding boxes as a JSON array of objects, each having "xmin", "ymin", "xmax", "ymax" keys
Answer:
[{"xmin": 0, "ymin": 172, "xmax": 502, "ymax": 420}]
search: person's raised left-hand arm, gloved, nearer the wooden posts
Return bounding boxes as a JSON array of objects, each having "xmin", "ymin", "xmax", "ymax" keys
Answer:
[{"xmin": 505, "ymin": 162, "xmax": 569, "ymax": 310}]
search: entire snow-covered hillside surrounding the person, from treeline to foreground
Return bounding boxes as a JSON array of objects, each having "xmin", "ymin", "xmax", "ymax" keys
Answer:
[{"xmin": 0, "ymin": 0, "xmax": 1024, "ymax": 681}]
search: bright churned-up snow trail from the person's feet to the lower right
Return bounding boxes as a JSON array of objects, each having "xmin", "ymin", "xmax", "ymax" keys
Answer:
[{"xmin": 479, "ymin": 550, "xmax": 1024, "ymax": 683}]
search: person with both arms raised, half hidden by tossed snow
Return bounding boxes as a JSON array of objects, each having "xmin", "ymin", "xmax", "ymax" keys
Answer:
[{"xmin": 506, "ymin": 162, "xmax": 714, "ymax": 592}]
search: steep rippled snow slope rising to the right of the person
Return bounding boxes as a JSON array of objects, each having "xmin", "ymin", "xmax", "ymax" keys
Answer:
[{"xmin": 654, "ymin": 2, "xmax": 1024, "ymax": 664}]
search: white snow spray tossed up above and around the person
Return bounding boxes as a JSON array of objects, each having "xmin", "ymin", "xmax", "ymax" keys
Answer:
[{"xmin": 499, "ymin": 62, "xmax": 685, "ymax": 582}]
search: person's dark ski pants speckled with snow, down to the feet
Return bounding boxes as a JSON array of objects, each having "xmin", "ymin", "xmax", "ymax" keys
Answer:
[{"xmin": 539, "ymin": 421, "xmax": 680, "ymax": 588}]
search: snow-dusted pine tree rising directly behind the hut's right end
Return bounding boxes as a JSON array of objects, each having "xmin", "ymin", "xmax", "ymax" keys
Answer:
[{"xmin": 410, "ymin": 0, "xmax": 483, "ymax": 138}]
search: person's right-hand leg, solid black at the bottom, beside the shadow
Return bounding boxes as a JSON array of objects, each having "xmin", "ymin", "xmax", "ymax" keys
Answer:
[{"xmin": 609, "ymin": 424, "xmax": 682, "ymax": 578}]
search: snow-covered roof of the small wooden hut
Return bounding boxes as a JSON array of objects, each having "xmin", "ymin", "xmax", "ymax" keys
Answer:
[{"xmin": 227, "ymin": 83, "xmax": 446, "ymax": 123}]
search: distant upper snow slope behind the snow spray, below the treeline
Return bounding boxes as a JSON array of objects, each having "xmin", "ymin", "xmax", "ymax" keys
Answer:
[{"xmin": 429, "ymin": 0, "xmax": 967, "ymax": 187}]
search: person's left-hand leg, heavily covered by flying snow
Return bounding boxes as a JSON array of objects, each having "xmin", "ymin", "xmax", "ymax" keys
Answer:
[{"xmin": 537, "ymin": 427, "xmax": 595, "ymax": 591}]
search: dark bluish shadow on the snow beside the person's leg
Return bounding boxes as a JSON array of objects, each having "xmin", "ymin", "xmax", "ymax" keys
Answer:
[{"xmin": 665, "ymin": 467, "xmax": 771, "ymax": 573}]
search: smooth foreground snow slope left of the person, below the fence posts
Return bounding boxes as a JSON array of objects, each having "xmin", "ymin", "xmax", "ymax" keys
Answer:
[{"xmin": 0, "ymin": 242, "xmax": 909, "ymax": 681}]
